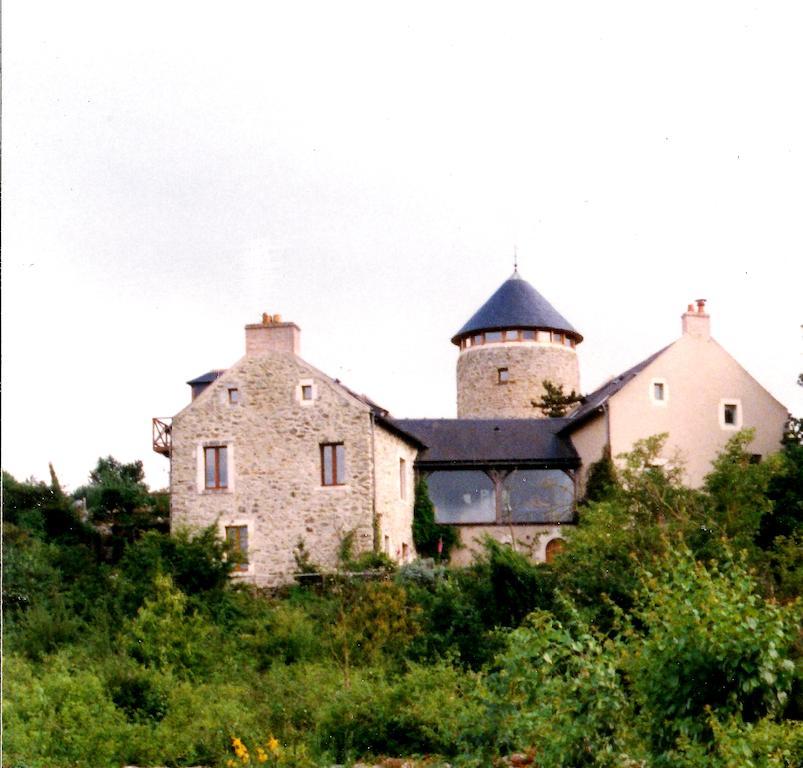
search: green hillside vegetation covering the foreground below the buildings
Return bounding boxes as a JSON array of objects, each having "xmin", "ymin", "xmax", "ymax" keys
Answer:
[{"xmin": 3, "ymin": 432, "xmax": 803, "ymax": 768}]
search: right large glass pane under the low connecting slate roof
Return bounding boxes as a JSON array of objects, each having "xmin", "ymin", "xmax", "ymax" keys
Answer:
[{"xmin": 502, "ymin": 469, "xmax": 574, "ymax": 523}]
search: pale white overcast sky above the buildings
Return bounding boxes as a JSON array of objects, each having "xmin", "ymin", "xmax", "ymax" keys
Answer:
[{"xmin": 2, "ymin": 0, "xmax": 803, "ymax": 490}]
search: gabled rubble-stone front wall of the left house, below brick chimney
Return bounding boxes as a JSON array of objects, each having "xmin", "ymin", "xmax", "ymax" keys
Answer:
[{"xmin": 171, "ymin": 352, "xmax": 374, "ymax": 585}]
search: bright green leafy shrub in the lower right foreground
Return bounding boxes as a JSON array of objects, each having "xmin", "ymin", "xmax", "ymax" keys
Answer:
[{"xmin": 629, "ymin": 552, "xmax": 801, "ymax": 754}]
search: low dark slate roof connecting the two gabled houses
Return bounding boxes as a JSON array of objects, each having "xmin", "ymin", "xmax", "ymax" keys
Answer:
[{"xmin": 386, "ymin": 419, "xmax": 580, "ymax": 468}]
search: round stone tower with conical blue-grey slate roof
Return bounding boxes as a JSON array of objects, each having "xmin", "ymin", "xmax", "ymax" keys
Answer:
[{"xmin": 452, "ymin": 271, "xmax": 583, "ymax": 419}]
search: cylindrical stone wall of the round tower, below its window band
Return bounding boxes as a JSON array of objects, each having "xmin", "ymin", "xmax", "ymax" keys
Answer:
[{"xmin": 457, "ymin": 342, "xmax": 580, "ymax": 419}]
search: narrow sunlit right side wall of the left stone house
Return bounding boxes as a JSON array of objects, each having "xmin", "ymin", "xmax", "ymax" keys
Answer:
[{"xmin": 374, "ymin": 426, "xmax": 416, "ymax": 562}]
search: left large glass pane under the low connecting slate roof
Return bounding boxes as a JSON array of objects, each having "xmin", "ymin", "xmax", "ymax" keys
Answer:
[{"xmin": 427, "ymin": 470, "xmax": 496, "ymax": 523}]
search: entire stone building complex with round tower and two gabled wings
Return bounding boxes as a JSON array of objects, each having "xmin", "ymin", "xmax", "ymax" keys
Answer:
[{"xmin": 154, "ymin": 272, "xmax": 786, "ymax": 585}]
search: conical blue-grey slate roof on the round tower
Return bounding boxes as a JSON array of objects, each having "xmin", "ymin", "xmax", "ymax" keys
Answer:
[{"xmin": 452, "ymin": 271, "xmax": 583, "ymax": 344}]
